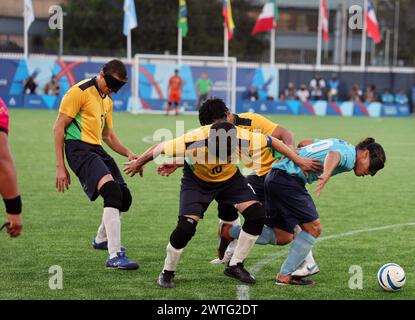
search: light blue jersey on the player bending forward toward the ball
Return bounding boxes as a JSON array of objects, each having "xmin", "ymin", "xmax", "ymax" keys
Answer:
[{"xmin": 272, "ymin": 139, "xmax": 356, "ymax": 183}]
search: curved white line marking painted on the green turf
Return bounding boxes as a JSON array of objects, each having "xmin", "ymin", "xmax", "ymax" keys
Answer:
[{"xmin": 236, "ymin": 222, "xmax": 415, "ymax": 300}]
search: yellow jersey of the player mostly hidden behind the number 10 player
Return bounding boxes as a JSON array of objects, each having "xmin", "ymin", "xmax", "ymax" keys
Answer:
[{"xmin": 234, "ymin": 112, "xmax": 278, "ymax": 176}]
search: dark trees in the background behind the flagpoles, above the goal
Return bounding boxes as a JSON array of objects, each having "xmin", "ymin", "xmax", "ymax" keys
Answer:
[{"xmin": 50, "ymin": 0, "xmax": 268, "ymax": 60}]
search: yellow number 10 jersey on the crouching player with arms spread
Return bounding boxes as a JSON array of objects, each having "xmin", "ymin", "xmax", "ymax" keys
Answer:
[{"xmin": 163, "ymin": 125, "xmax": 270, "ymax": 182}]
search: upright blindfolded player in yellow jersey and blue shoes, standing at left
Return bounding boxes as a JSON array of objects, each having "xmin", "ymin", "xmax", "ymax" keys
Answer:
[{"xmin": 54, "ymin": 60, "xmax": 138, "ymax": 270}]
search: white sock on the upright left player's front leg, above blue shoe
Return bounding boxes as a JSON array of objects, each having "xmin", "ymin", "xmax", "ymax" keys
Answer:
[{"xmin": 102, "ymin": 207, "xmax": 121, "ymax": 259}]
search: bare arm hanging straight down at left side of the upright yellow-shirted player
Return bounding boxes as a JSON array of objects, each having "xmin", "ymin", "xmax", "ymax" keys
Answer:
[{"xmin": 53, "ymin": 113, "xmax": 72, "ymax": 192}]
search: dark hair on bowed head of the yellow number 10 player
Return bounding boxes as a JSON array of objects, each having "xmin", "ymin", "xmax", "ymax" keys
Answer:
[{"xmin": 208, "ymin": 122, "xmax": 238, "ymax": 162}]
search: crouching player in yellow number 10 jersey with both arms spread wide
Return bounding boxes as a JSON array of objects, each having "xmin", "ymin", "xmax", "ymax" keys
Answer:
[{"xmin": 124, "ymin": 107, "xmax": 318, "ymax": 288}]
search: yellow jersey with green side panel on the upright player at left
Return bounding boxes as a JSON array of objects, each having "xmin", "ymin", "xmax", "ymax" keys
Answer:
[{"xmin": 59, "ymin": 78, "xmax": 113, "ymax": 145}]
